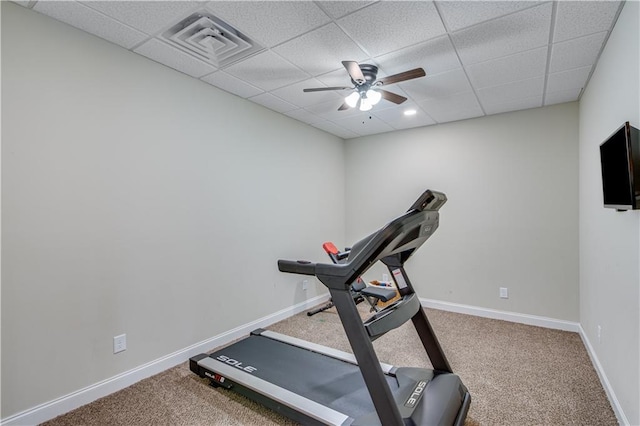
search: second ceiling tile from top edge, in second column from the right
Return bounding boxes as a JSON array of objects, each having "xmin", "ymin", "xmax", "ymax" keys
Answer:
[{"xmin": 451, "ymin": 3, "xmax": 552, "ymax": 65}]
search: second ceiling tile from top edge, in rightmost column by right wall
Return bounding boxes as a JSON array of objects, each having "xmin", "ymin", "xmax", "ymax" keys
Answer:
[{"xmin": 549, "ymin": 31, "xmax": 607, "ymax": 72}]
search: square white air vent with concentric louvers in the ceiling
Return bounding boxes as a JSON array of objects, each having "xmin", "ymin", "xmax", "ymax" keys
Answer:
[{"xmin": 162, "ymin": 11, "xmax": 264, "ymax": 68}]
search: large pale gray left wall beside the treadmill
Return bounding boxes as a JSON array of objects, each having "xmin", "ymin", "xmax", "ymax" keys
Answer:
[{"xmin": 2, "ymin": 2, "xmax": 344, "ymax": 418}]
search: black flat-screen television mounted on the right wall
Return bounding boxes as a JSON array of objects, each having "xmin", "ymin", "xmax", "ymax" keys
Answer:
[{"xmin": 600, "ymin": 122, "xmax": 640, "ymax": 210}]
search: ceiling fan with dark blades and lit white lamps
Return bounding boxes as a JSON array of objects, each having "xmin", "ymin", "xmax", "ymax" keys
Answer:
[{"xmin": 302, "ymin": 61, "xmax": 426, "ymax": 111}]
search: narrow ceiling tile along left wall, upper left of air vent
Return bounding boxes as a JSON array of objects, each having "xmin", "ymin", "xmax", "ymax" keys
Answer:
[{"xmin": 33, "ymin": 1, "xmax": 148, "ymax": 49}]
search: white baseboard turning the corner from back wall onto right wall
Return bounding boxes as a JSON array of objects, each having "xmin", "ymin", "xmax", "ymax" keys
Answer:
[{"xmin": 420, "ymin": 298, "xmax": 630, "ymax": 425}]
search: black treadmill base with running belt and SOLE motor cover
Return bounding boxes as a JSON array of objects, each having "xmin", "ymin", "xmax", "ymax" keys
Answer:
[{"xmin": 190, "ymin": 330, "xmax": 469, "ymax": 426}]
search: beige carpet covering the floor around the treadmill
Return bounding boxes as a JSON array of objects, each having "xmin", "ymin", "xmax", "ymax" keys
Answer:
[{"xmin": 45, "ymin": 309, "xmax": 617, "ymax": 426}]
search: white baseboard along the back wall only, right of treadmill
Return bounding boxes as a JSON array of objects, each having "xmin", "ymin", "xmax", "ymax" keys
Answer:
[{"xmin": 420, "ymin": 298, "xmax": 580, "ymax": 333}]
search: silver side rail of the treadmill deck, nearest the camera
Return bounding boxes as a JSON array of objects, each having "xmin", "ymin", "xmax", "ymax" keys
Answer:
[{"xmin": 198, "ymin": 357, "xmax": 353, "ymax": 426}]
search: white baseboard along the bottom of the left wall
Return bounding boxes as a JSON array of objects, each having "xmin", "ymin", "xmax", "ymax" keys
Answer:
[{"xmin": 0, "ymin": 294, "xmax": 329, "ymax": 426}]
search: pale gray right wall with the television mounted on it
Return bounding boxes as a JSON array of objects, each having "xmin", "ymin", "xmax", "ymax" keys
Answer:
[{"xmin": 580, "ymin": 2, "xmax": 640, "ymax": 425}]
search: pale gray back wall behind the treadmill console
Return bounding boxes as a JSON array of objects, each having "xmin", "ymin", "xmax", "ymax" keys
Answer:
[{"xmin": 346, "ymin": 103, "xmax": 579, "ymax": 321}]
